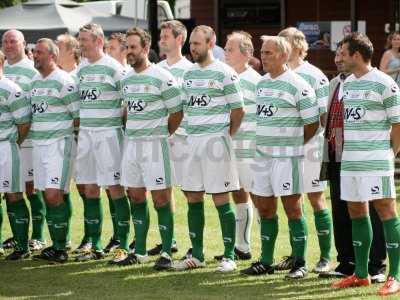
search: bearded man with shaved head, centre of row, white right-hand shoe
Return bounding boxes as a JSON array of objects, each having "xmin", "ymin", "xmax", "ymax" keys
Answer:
[{"xmin": 174, "ymin": 25, "xmax": 244, "ymax": 272}]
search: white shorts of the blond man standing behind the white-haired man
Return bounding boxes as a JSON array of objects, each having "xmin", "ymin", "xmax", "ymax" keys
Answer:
[{"xmin": 303, "ymin": 131, "xmax": 326, "ymax": 193}]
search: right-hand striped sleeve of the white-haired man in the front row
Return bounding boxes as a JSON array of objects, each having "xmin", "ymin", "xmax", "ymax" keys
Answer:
[{"xmin": 296, "ymin": 85, "xmax": 319, "ymax": 125}]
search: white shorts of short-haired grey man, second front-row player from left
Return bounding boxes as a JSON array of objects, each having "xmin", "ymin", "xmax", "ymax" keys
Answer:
[{"xmin": 33, "ymin": 136, "xmax": 76, "ymax": 193}]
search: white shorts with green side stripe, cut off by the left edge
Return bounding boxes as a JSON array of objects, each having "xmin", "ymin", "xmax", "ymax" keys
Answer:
[{"xmin": 0, "ymin": 141, "xmax": 25, "ymax": 193}]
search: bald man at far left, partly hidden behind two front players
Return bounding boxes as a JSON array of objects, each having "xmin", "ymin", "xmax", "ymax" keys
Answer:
[{"xmin": 2, "ymin": 29, "xmax": 46, "ymax": 250}]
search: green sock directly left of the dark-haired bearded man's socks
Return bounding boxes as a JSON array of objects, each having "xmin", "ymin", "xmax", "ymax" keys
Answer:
[{"xmin": 110, "ymin": 197, "xmax": 130, "ymax": 251}]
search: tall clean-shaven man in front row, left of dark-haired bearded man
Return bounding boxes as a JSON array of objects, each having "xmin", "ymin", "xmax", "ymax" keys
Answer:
[{"xmin": 76, "ymin": 24, "xmax": 130, "ymax": 261}]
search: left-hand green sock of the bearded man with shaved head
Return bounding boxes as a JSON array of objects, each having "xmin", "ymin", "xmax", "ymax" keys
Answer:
[{"xmin": 187, "ymin": 201, "xmax": 204, "ymax": 261}]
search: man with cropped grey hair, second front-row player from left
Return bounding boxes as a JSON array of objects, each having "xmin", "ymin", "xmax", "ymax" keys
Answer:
[{"xmin": 30, "ymin": 38, "xmax": 79, "ymax": 263}]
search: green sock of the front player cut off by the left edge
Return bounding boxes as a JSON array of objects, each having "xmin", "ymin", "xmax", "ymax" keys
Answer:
[{"xmin": 7, "ymin": 198, "xmax": 29, "ymax": 251}]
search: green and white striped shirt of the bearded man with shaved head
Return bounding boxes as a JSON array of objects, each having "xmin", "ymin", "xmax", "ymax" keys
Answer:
[{"xmin": 183, "ymin": 60, "xmax": 244, "ymax": 135}]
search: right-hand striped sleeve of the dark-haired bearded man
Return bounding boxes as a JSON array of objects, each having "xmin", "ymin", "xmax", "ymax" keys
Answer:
[{"xmin": 161, "ymin": 75, "xmax": 183, "ymax": 114}]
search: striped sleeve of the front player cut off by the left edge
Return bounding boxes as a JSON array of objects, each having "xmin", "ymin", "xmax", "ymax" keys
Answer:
[{"xmin": 8, "ymin": 88, "xmax": 32, "ymax": 125}]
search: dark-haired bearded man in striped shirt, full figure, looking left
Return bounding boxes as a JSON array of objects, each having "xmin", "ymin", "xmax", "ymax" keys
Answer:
[{"xmin": 114, "ymin": 27, "xmax": 183, "ymax": 270}]
